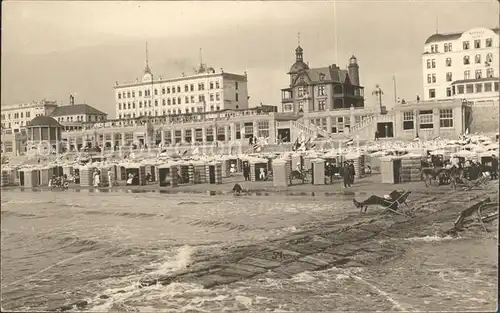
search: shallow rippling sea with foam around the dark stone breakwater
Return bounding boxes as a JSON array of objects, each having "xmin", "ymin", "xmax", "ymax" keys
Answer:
[{"xmin": 1, "ymin": 190, "xmax": 497, "ymax": 312}]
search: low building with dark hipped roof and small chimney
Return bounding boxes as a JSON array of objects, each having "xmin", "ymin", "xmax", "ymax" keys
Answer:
[{"xmin": 50, "ymin": 96, "xmax": 108, "ymax": 130}]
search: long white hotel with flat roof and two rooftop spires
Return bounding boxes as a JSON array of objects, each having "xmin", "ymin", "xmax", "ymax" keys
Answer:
[{"xmin": 114, "ymin": 62, "xmax": 248, "ymax": 119}]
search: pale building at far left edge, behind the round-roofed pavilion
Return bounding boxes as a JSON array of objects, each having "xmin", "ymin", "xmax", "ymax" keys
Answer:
[{"xmin": 1, "ymin": 100, "xmax": 57, "ymax": 133}]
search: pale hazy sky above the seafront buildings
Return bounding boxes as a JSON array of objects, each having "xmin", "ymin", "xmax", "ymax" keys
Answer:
[{"xmin": 1, "ymin": 0, "xmax": 500, "ymax": 117}]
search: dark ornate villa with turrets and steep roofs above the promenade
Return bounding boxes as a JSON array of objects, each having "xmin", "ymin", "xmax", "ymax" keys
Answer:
[{"xmin": 280, "ymin": 46, "xmax": 370, "ymax": 134}]
